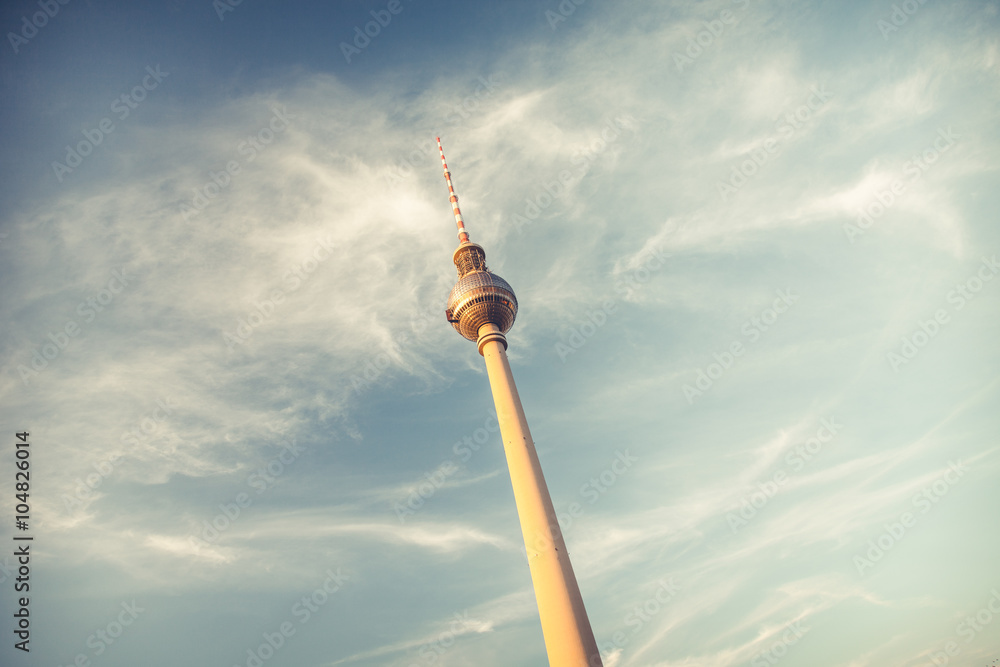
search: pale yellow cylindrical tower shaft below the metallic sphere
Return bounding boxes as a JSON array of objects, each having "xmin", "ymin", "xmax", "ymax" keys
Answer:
[{"xmin": 479, "ymin": 324, "xmax": 602, "ymax": 667}]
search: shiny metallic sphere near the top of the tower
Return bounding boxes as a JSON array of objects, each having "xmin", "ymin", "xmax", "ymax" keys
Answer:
[{"xmin": 445, "ymin": 270, "xmax": 517, "ymax": 341}]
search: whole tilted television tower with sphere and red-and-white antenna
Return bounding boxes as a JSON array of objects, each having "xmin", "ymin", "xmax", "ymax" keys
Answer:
[{"xmin": 437, "ymin": 137, "xmax": 603, "ymax": 667}]
